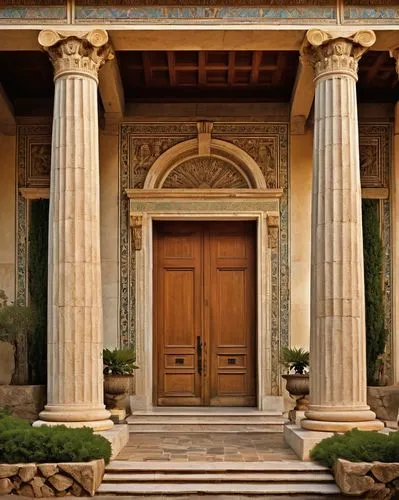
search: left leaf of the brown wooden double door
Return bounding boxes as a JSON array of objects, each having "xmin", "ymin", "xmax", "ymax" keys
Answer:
[{"xmin": 154, "ymin": 224, "xmax": 202, "ymax": 406}]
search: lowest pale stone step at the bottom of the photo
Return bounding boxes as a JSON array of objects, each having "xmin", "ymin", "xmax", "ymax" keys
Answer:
[{"xmin": 97, "ymin": 482, "xmax": 340, "ymax": 496}]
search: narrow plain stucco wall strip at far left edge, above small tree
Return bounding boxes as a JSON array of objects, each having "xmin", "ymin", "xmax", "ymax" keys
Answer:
[{"xmin": 0, "ymin": 135, "xmax": 16, "ymax": 300}]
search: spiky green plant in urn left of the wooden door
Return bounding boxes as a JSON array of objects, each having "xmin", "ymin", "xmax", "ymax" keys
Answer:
[{"xmin": 103, "ymin": 349, "xmax": 138, "ymax": 410}]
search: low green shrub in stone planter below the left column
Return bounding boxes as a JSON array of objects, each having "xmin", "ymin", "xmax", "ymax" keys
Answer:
[{"xmin": 0, "ymin": 414, "xmax": 111, "ymax": 464}]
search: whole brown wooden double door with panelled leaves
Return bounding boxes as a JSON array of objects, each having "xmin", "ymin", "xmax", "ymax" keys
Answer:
[{"xmin": 154, "ymin": 222, "xmax": 256, "ymax": 406}]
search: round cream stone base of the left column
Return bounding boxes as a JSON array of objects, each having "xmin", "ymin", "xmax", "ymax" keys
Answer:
[{"xmin": 33, "ymin": 404, "xmax": 114, "ymax": 431}]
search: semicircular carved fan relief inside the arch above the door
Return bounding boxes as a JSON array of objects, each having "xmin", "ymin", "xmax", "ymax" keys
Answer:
[{"xmin": 162, "ymin": 157, "xmax": 250, "ymax": 189}]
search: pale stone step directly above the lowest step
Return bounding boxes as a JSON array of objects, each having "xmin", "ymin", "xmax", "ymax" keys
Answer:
[{"xmin": 103, "ymin": 471, "xmax": 334, "ymax": 483}]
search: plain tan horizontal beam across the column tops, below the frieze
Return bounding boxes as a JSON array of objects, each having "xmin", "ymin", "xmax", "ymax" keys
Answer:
[{"xmin": 0, "ymin": 29, "xmax": 399, "ymax": 50}]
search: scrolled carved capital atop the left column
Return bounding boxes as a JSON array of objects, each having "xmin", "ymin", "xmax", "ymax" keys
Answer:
[{"xmin": 39, "ymin": 29, "xmax": 114, "ymax": 82}]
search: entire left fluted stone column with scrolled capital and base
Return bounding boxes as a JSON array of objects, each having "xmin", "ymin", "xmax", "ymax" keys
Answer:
[{"xmin": 35, "ymin": 30, "xmax": 113, "ymax": 430}]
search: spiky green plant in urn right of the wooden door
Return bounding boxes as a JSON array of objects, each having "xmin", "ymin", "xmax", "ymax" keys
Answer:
[{"xmin": 280, "ymin": 347, "xmax": 309, "ymax": 411}]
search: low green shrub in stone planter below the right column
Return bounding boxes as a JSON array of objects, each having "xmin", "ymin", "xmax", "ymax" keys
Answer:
[{"xmin": 310, "ymin": 429, "xmax": 399, "ymax": 468}]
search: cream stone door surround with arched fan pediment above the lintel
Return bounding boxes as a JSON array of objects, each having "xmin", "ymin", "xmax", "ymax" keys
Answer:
[{"xmin": 126, "ymin": 136, "xmax": 283, "ymax": 411}]
